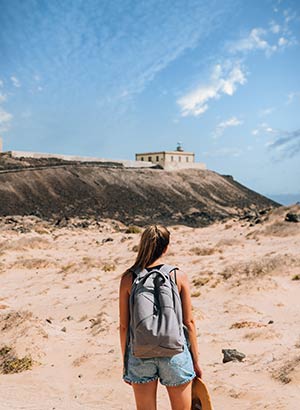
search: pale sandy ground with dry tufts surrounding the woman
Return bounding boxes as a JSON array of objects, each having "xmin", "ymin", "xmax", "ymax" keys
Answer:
[{"xmin": 0, "ymin": 207, "xmax": 300, "ymax": 410}]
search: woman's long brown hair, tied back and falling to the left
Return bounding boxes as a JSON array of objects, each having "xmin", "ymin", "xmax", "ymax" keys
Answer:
[{"xmin": 129, "ymin": 225, "xmax": 170, "ymax": 270}]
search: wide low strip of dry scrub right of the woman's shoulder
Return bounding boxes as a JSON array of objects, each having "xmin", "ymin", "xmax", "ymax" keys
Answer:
[{"xmin": 220, "ymin": 255, "xmax": 300, "ymax": 279}]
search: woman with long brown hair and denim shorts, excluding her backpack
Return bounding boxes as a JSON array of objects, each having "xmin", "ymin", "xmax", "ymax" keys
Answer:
[{"xmin": 119, "ymin": 225, "xmax": 202, "ymax": 410}]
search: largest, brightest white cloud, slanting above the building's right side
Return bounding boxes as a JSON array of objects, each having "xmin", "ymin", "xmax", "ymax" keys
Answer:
[{"xmin": 177, "ymin": 62, "xmax": 246, "ymax": 117}]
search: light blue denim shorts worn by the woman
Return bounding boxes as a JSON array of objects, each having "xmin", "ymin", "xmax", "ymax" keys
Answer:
[{"xmin": 123, "ymin": 344, "xmax": 196, "ymax": 386}]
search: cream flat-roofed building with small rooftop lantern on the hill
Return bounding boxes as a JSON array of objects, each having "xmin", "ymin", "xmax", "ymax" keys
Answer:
[{"xmin": 135, "ymin": 143, "xmax": 206, "ymax": 170}]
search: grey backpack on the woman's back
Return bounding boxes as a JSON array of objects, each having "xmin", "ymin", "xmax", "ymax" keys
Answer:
[{"xmin": 130, "ymin": 265, "xmax": 185, "ymax": 358}]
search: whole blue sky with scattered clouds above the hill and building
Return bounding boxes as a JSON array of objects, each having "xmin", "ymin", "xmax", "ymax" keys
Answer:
[{"xmin": 0, "ymin": 0, "xmax": 300, "ymax": 201}]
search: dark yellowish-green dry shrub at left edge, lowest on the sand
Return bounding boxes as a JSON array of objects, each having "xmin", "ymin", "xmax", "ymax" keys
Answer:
[{"xmin": 0, "ymin": 346, "xmax": 33, "ymax": 374}]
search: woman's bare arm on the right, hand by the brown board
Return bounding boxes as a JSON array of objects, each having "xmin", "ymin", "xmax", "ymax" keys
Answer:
[{"xmin": 177, "ymin": 271, "xmax": 202, "ymax": 377}]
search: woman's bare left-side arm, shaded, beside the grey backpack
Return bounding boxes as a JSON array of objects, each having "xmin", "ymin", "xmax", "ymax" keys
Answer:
[{"xmin": 119, "ymin": 274, "xmax": 132, "ymax": 360}]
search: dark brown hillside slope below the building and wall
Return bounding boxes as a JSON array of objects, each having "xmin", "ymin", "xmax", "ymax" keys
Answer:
[{"xmin": 0, "ymin": 165, "xmax": 278, "ymax": 226}]
